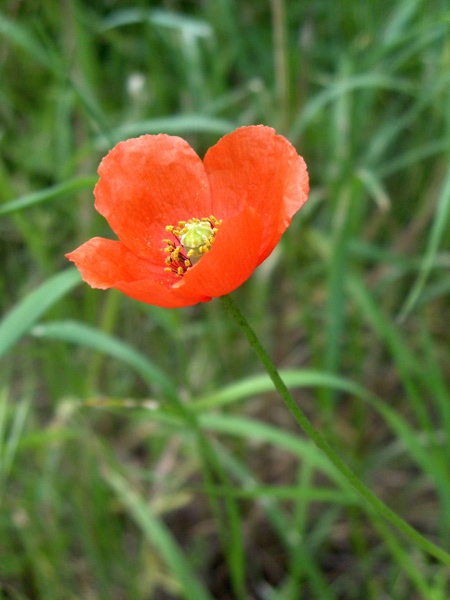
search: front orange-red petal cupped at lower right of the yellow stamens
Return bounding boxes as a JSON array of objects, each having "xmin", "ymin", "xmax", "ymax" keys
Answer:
[{"xmin": 175, "ymin": 206, "xmax": 263, "ymax": 298}]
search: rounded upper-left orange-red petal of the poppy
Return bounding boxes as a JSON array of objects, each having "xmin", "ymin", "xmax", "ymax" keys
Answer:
[{"xmin": 94, "ymin": 134, "xmax": 211, "ymax": 263}]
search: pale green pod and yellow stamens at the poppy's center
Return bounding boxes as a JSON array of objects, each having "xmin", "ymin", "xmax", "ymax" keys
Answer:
[{"xmin": 163, "ymin": 215, "xmax": 222, "ymax": 277}]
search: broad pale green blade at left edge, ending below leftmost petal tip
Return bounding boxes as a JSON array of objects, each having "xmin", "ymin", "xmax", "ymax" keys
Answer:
[{"xmin": 0, "ymin": 267, "xmax": 81, "ymax": 358}]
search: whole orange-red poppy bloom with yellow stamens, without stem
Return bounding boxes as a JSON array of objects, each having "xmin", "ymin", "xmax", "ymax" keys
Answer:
[{"xmin": 67, "ymin": 125, "xmax": 309, "ymax": 308}]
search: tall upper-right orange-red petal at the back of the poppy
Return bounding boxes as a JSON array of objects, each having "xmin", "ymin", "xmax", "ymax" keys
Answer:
[{"xmin": 204, "ymin": 125, "xmax": 309, "ymax": 263}]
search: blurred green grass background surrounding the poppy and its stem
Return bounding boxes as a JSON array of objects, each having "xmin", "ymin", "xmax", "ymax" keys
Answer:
[{"xmin": 0, "ymin": 0, "xmax": 450, "ymax": 600}]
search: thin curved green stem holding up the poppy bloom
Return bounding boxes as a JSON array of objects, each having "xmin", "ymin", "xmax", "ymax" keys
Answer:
[{"xmin": 221, "ymin": 296, "xmax": 450, "ymax": 565}]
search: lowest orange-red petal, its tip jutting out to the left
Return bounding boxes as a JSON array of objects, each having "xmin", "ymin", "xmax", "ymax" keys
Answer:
[{"xmin": 66, "ymin": 238, "xmax": 211, "ymax": 308}]
